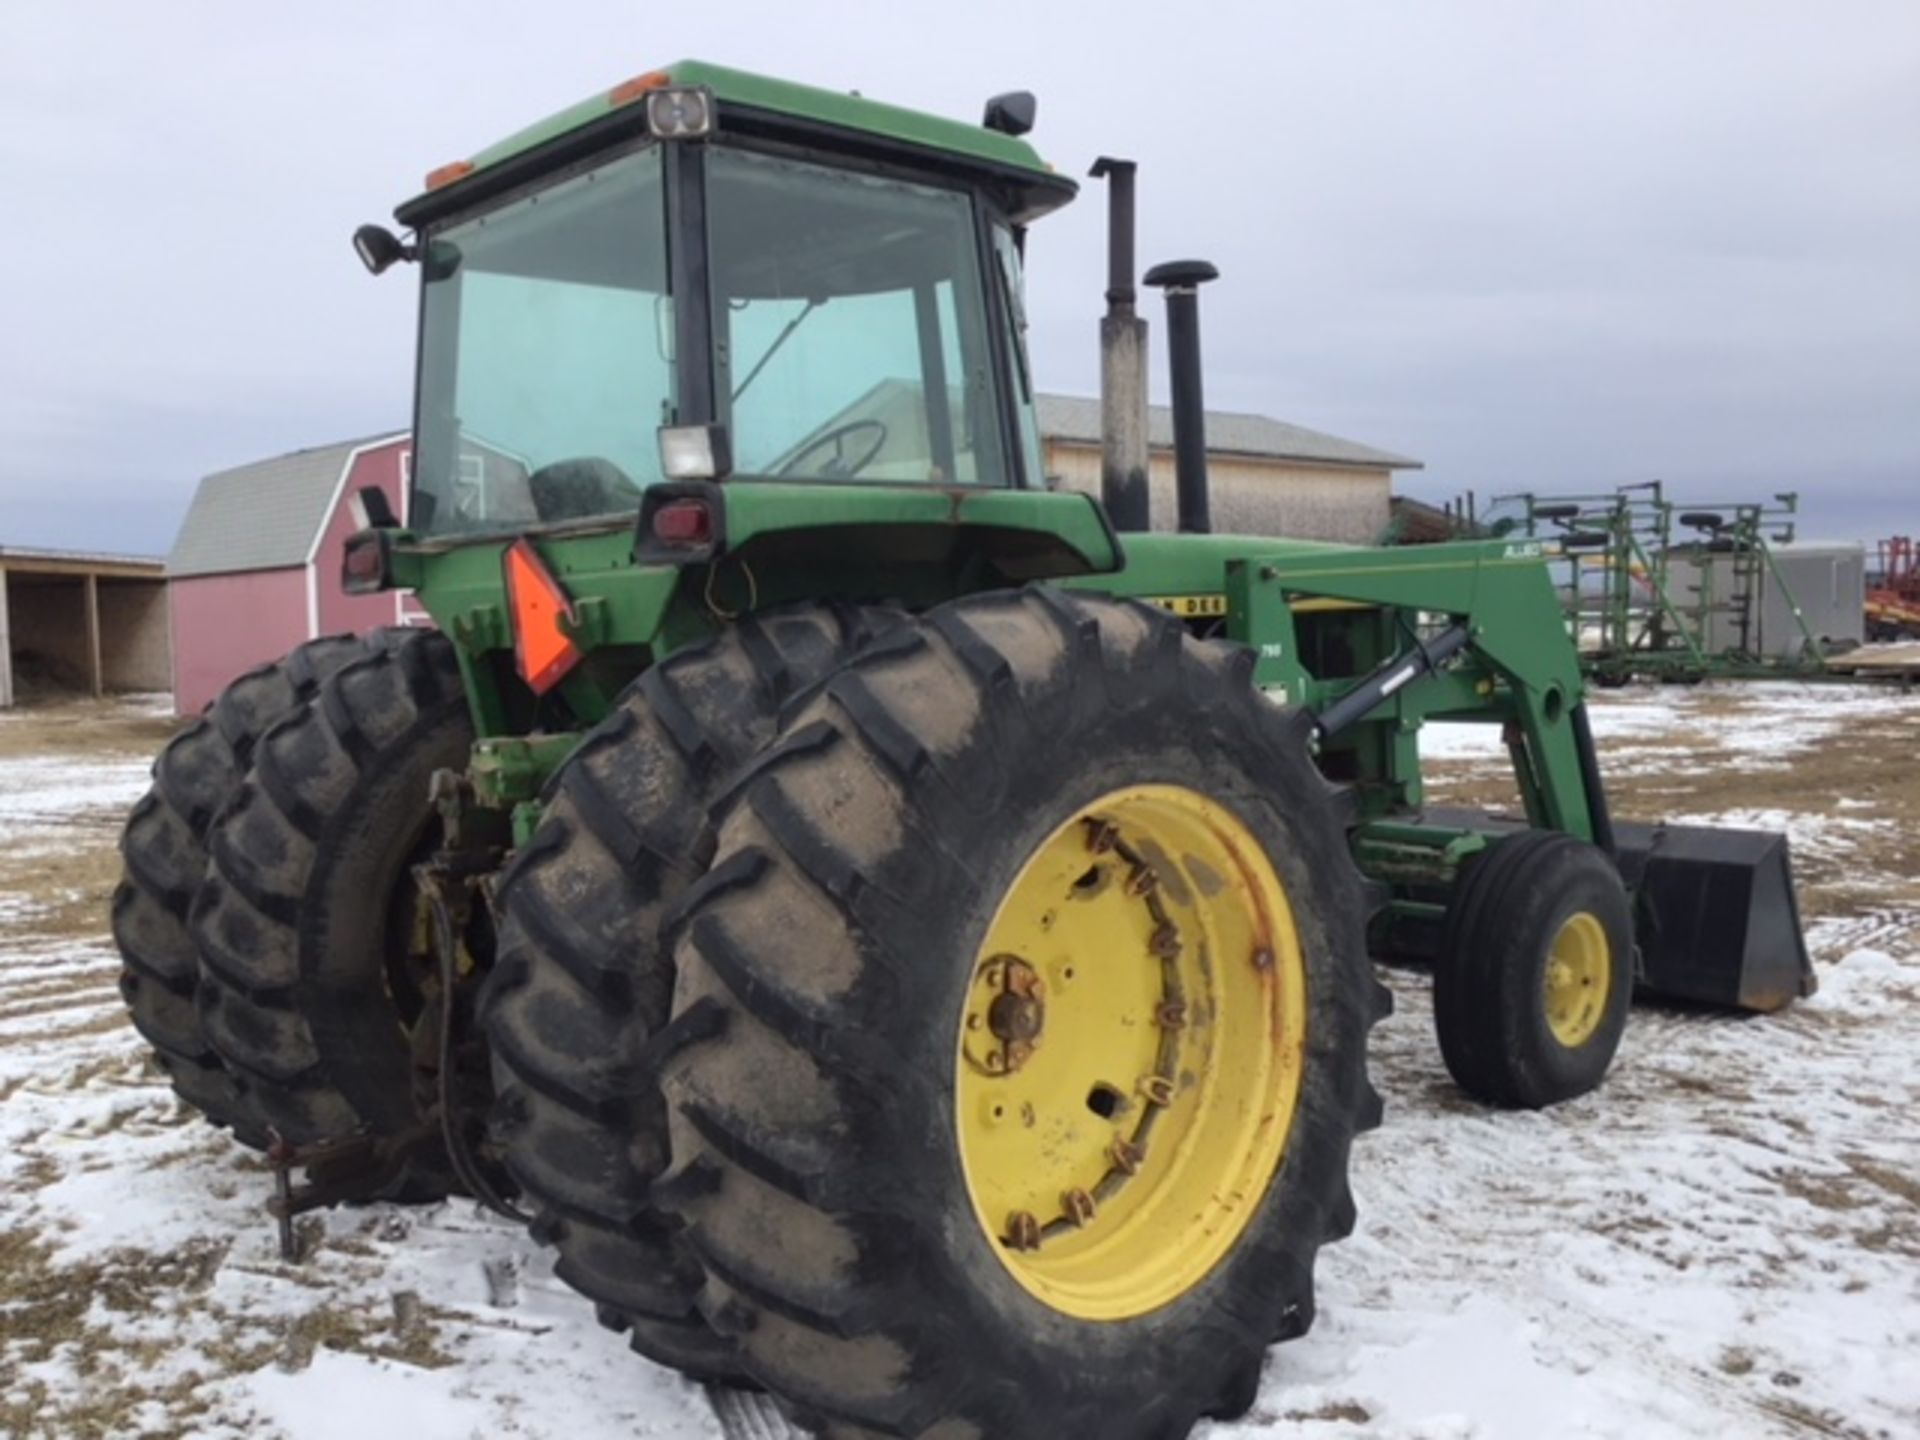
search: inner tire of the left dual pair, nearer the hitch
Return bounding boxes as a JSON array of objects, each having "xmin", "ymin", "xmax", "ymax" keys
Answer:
[{"xmin": 192, "ymin": 630, "xmax": 488, "ymax": 1200}]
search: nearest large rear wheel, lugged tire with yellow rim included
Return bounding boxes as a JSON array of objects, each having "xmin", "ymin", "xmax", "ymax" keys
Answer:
[{"xmin": 655, "ymin": 588, "xmax": 1386, "ymax": 1440}]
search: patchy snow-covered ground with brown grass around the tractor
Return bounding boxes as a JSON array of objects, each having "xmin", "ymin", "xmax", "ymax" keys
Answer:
[{"xmin": 0, "ymin": 685, "xmax": 1920, "ymax": 1440}]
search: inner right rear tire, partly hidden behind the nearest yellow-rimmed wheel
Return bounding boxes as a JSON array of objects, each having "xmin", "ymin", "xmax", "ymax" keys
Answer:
[{"xmin": 482, "ymin": 605, "xmax": 904, "ymax": 1380}]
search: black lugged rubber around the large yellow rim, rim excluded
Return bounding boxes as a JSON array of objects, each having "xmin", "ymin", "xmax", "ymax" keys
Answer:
[{"xmin": 655, "ymin": 586, "xmax": 1386, "ymax": 1440}]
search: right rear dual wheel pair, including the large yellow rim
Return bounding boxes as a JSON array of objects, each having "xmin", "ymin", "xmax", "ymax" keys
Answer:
[{"xmin": 484, "ymin": 589, "xmax": 1386, "ymax": 1440}]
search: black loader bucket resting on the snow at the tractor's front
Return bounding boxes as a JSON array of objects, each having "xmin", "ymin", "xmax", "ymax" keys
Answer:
[{"xmin": 1617, "ymin": 822, "xmax": 1816, "ymax": 1010}]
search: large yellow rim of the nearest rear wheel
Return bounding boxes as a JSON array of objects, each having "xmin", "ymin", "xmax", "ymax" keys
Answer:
[{"xmin": 954, "ymin": 785, "xmax": 1308, "ymax": 1321}]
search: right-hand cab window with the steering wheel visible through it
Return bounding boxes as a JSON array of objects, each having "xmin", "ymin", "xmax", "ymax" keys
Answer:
[{"xmin": 707, "ymin": 148, "xmax": 1010, "ymax": 486}]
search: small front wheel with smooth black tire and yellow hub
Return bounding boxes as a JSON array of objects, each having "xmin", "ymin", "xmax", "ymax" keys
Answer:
[{"xmin": 1434, "ymin": 829, "xmax": 1634, "ymax": 1110}]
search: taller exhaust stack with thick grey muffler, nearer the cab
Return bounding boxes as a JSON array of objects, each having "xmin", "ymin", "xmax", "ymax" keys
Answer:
[{"xmin": 1092, "ymin": 156, "xmax": 1152, "ymax": 530}]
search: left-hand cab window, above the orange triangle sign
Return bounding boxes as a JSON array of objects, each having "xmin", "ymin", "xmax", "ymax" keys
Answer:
[{"xmin": 409, "ymin": 146, "xmax": 674, "ymax": 534}]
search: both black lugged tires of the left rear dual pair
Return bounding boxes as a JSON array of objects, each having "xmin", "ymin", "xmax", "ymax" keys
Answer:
[{"xmin": 113, "ymin": 630, "xmax": 472, "ymax": 1200}]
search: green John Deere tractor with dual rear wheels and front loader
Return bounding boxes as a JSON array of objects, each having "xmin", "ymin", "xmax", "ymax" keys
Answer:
[{"xmin": 113, "ymin": 63, "xmax": 1812, "ymax": 1440}]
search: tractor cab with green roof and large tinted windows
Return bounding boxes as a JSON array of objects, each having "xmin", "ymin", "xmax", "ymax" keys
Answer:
[{"xmin": 361, "ymin": 63, "xmax": 1075, "ymax": 538}]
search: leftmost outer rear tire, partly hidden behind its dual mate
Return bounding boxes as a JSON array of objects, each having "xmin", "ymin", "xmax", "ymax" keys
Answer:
[{"xmin": 113, "ymin": 636, "xmax": 363, "ymax": 1148}]
